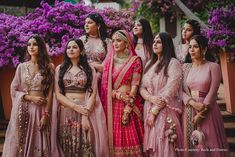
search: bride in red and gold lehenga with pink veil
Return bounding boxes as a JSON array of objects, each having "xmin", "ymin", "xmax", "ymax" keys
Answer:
[{"xmin": 101, "ymin": 30, "xmax": 144, "ymax": 157}]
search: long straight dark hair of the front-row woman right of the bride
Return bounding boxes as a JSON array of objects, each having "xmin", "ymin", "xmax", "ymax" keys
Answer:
[{"xmin": 144, "ymin": 32, "xmax": 176, "ymax": 76}]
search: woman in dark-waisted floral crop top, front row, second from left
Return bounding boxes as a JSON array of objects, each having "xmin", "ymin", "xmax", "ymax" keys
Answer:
[{"xmin": 51, "ymin": 39, "xmax": 108, "ymax": 157}]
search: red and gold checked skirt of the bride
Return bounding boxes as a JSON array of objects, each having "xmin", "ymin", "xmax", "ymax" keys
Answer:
[{"xmin": 113, "ymin": 96, "xmax": 144, "ymax": 157}]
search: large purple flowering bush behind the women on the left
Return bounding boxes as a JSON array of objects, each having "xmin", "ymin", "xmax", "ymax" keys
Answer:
[{"xmin": 0, "ymin": 2, "xmax": 134, "ymax": 68}]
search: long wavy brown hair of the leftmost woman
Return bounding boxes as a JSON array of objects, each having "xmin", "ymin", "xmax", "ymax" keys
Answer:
[{"xmin": 28, "ymin": 35, "xmax": 54, "ymax": 96}]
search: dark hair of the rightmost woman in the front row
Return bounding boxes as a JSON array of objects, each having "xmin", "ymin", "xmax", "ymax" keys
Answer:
[{"xmin": 185, "ymin": 35, "xmax": 216, "ymax": 63}]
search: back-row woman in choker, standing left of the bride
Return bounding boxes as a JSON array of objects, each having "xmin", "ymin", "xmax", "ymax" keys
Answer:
[{"xmin": 80, "ymin": 13, "xmax": 111, "ymax": 73}]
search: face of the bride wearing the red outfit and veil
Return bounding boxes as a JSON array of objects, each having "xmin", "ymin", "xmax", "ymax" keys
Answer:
[{"xmin": 112, "ymin": 33, "xmax": 128, "ymax": 52}]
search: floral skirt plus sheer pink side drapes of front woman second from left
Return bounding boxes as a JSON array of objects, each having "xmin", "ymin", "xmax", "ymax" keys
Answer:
[{"xmin": 51, "ymin": 96, "xmax": 109, "ymax": 157}]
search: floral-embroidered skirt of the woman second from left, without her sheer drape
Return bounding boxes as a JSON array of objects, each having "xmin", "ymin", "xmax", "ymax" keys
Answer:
[{"xmin": 57, "ymin": 99, "xmax": 94, "ymax": 157}]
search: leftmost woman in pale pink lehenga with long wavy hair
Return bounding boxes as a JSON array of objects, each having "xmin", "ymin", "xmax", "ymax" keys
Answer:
[{"xmin": 2, "ymin": 35, "xmax": 54, "ymax": 157}]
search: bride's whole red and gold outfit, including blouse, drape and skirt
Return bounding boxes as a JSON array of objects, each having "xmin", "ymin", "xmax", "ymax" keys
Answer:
[{"xmin": 101, "ymin": 31, "xmax": 144, "ymax": 157}]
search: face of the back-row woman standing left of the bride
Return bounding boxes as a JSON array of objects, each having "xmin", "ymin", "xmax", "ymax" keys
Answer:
[{"xmin": 84, "ymin": 18, "xmax": 99, "ymax": 35}]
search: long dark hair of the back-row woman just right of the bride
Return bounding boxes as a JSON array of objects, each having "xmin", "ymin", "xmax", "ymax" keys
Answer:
[{"xmin": 133, "ymin": 18, "xmax": 153, "ymax": 56}]
